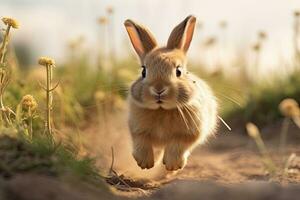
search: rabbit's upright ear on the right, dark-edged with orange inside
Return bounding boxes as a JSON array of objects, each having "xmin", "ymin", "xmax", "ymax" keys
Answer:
[{"xmin": 167, "ymin": 15, "xmax": 196, "ymax": 52}]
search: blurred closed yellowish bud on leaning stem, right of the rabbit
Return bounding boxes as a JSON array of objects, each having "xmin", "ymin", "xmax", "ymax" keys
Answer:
[{"xmin": 246, "ymin": 122, "xmax": 277, "ymax": 175}]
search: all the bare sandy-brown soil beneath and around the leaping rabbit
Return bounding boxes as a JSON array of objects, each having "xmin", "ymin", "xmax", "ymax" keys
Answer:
[{"xmin": 0, "ymin": 118, "xmax": 300, "ymax": 200}]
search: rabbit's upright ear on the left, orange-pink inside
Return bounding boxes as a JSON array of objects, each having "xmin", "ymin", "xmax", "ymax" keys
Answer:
[{"xmin": 124, "ymin": 19, "xmax": 157, "ymax": 60}]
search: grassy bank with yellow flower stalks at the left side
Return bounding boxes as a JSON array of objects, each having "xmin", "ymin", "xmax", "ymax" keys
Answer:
[{"xmin": 0, "ymin": 18, "xmax": 106, "ymax": 188}]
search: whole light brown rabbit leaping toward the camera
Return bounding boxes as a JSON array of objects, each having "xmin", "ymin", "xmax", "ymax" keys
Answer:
[{"xmin": 124, "ymin": 15, "xmax": 218, "ymax": 171}]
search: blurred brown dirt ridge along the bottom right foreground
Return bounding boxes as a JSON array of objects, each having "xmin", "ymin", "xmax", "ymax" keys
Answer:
[{"xmin": 146, "ymin": 180, "xmax": 300, "ymax": 200}]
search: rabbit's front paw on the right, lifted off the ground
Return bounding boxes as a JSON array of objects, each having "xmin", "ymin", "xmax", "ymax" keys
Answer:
[{"xmin": 163, "ymin": 154, "xmax": 186, "ymax": 171}]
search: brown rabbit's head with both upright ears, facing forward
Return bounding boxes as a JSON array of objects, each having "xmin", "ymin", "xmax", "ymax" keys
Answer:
[{"xmin": 125, "ymin": 16, "xmax": 196, "ymax": 109}]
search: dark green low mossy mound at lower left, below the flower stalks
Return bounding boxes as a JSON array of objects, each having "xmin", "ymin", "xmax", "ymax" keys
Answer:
[{"xmin": 0, "ymin": 132, "xmax": 100, "ymax": 183}]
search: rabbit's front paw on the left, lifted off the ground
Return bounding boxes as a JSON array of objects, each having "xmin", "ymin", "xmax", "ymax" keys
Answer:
[{"xmin": 132, "ymin": 149, "xmax": 154, "ymax": 169}]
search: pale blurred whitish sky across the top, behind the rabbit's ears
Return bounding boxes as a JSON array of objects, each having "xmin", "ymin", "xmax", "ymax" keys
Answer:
[{"xmin": 0, "ymin": 0, "xmax": 300, "ymax": 72}]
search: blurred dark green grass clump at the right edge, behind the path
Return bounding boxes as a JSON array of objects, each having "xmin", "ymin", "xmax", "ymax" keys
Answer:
[{"xmin": 230, "ymin": 70, "xmax": 300, "ymax": 125}]
